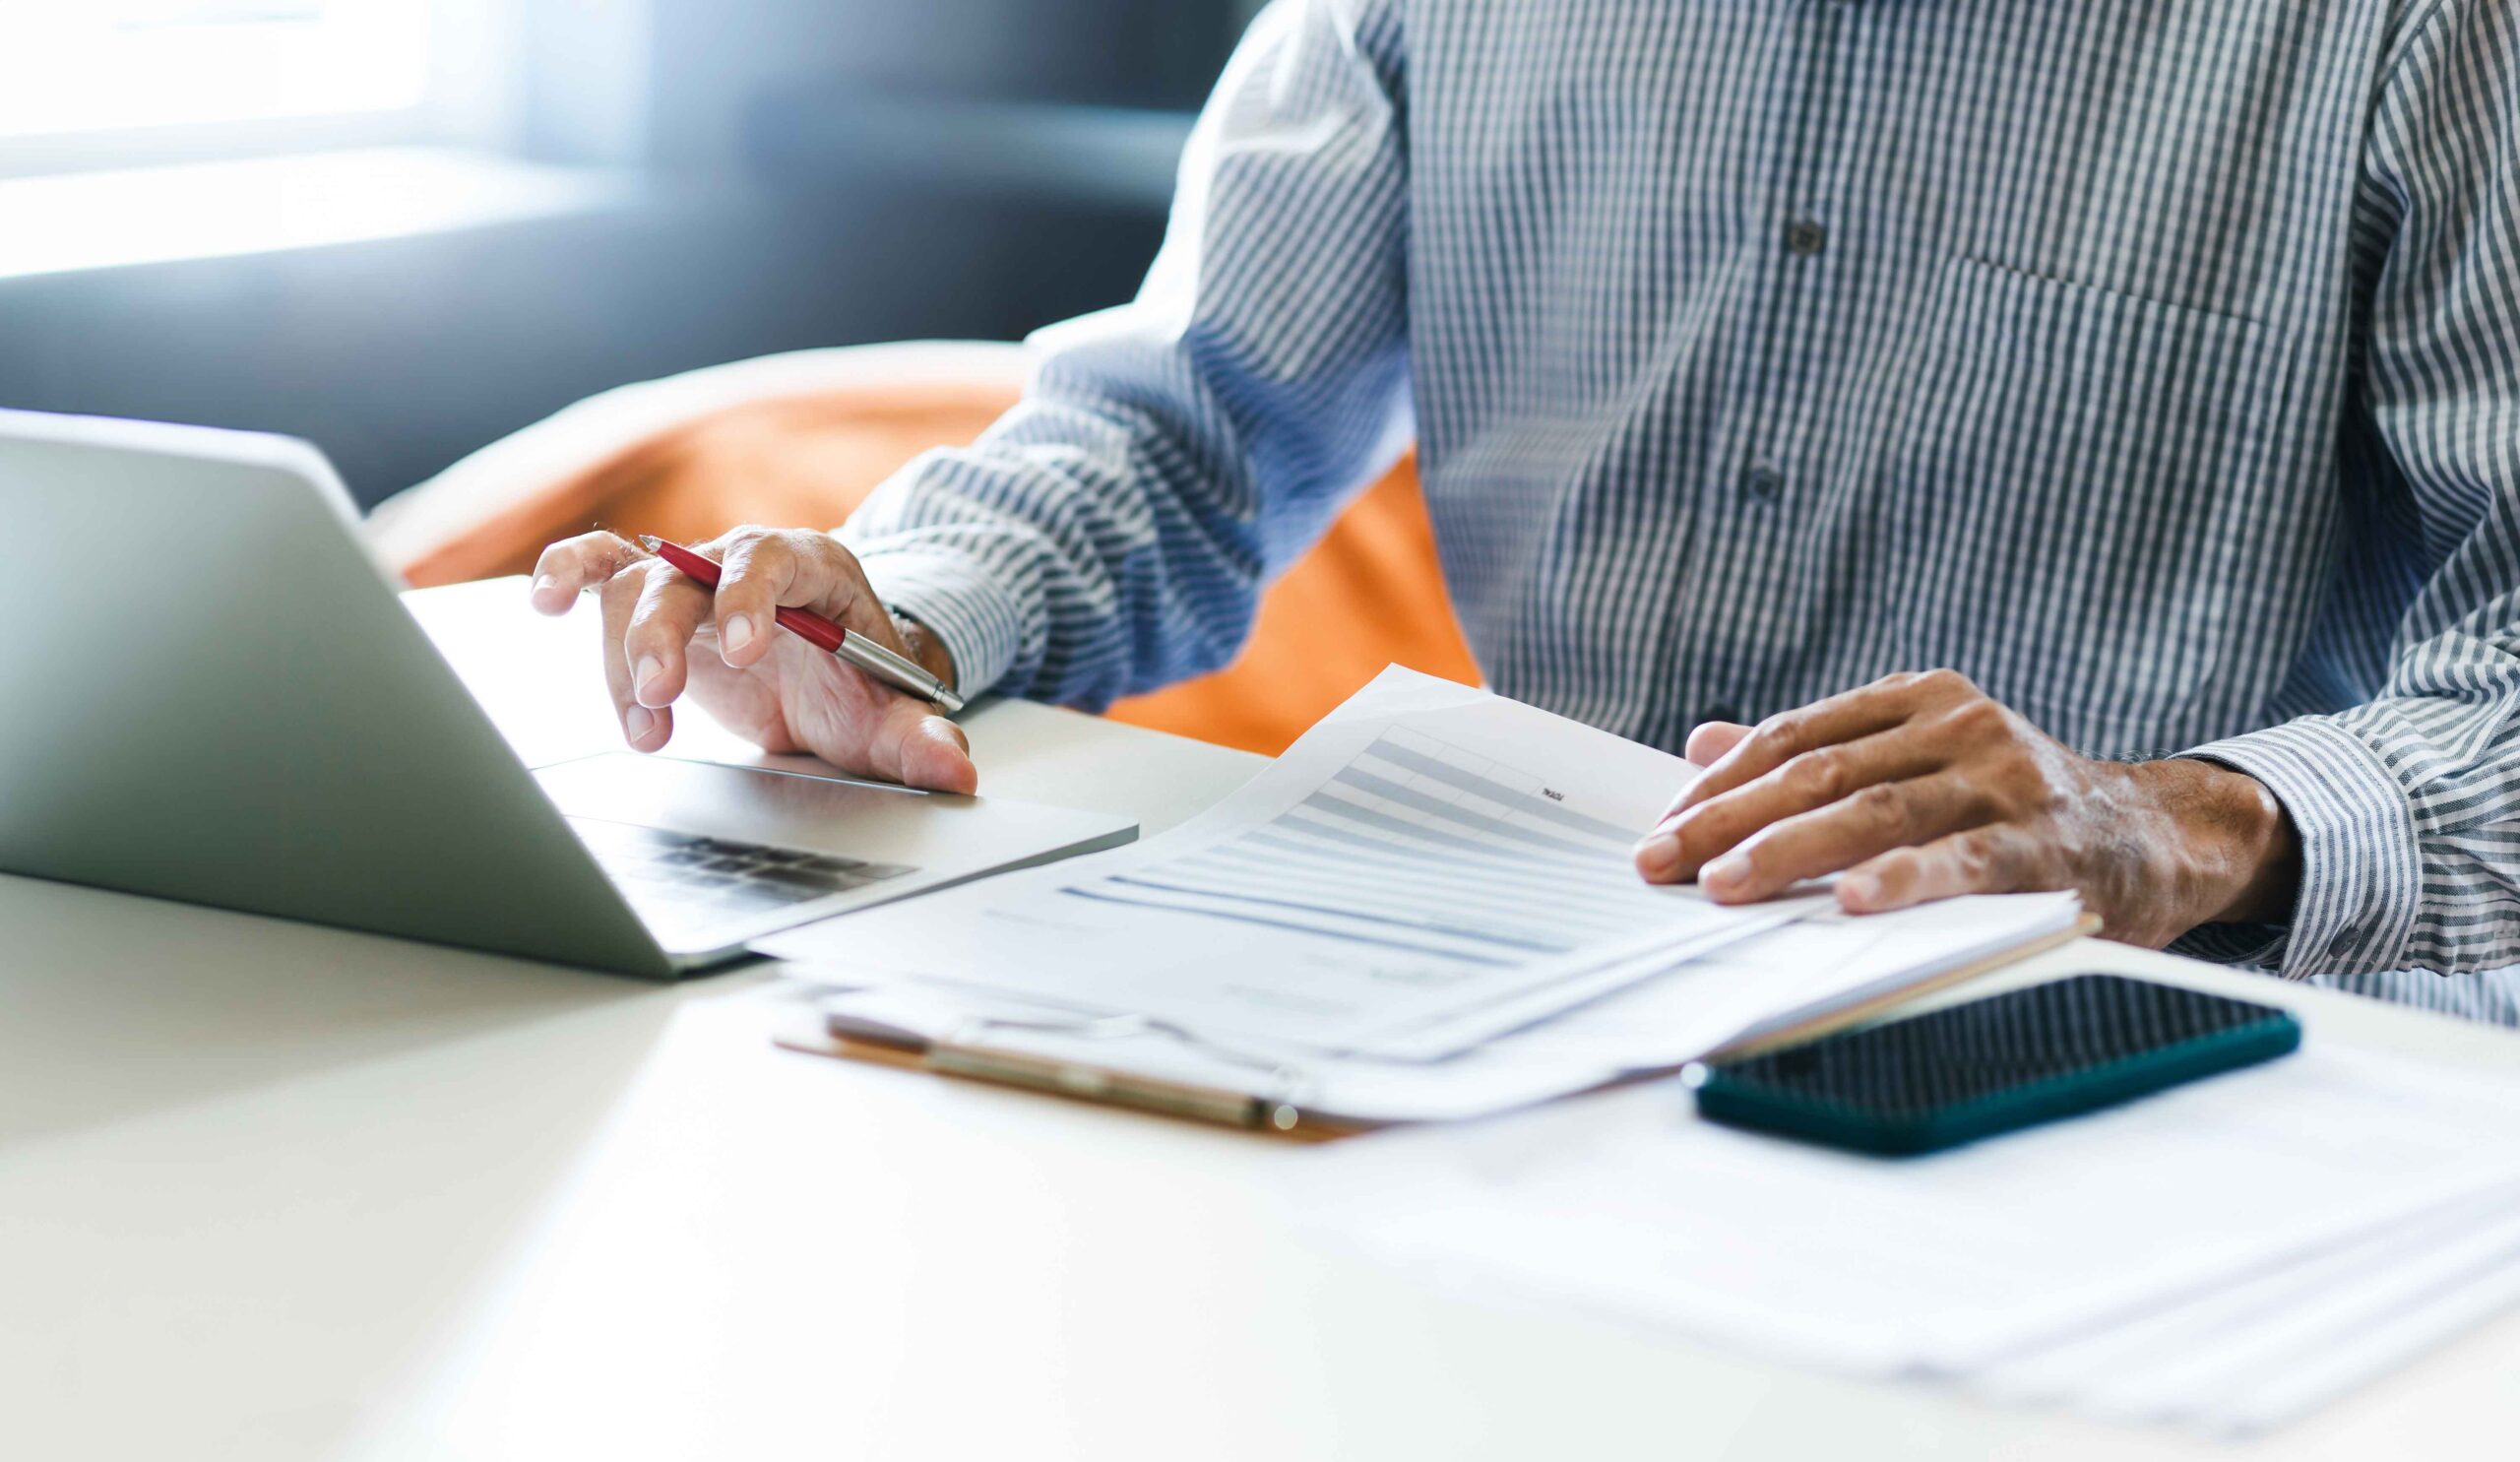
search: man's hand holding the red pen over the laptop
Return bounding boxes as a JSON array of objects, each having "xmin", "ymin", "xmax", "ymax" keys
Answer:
[{"xmin": 532, "ymin": 527, "xmax": 980, "ymax": 792}]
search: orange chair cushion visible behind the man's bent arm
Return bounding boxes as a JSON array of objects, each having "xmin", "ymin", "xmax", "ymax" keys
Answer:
[{"xmin": 396, "ymin": 383, "xmax": 1480, "ymax": 754}]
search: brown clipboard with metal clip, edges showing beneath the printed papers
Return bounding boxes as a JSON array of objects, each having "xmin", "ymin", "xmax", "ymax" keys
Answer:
[{"xmin": 774, "ymin": 915, "xmax": 2099, "ymax": 1142}]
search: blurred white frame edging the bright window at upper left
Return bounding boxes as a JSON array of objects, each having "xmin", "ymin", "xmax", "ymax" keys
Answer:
[{"xmin": 0, "ymin": 0, "xmax": 524, "ymax": 176}]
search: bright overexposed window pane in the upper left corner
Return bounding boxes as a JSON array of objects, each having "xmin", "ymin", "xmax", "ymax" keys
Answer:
[{"xmin": 0, "ymin": 0, "xmax": 507, "ymax": 171}]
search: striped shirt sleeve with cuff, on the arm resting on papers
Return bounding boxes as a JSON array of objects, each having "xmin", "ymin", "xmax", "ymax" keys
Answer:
[{"xmin": 2195, "ymin": 0, "xmax": 2520, "ymax": 976}]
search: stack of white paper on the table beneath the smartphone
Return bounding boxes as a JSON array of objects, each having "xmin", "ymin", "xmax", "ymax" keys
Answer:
[{"xmin": 1303, "ymin": 1049, "xmax": 2520, "ymax": 1431}]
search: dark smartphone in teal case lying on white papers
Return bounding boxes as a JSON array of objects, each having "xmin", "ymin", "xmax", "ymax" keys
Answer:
[{"xmin": 1683, "ymin": 976, "xmax": 2300, "ymax": 1155}]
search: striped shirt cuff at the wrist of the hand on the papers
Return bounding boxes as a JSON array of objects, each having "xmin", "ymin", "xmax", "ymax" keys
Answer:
[{"xmin": 2182, "ymin": 719, "xmax": 2425, "ymax": 981}]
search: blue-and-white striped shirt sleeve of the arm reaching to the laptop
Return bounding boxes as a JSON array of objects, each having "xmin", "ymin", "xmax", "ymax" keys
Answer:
[{"xmin": 842, "ymin": 0, "xmax": 1409, "ymax": 706}]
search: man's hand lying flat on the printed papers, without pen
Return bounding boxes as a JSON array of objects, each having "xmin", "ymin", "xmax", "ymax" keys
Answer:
[{"xmin": 1635, "ymin": 670, "xmax": 2300, "ymax": 948}]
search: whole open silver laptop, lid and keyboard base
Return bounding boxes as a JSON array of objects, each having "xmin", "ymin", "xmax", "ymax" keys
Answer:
[{"xmin": 0, "ymin": 411, "xmax": 1137, "ymax": 978}]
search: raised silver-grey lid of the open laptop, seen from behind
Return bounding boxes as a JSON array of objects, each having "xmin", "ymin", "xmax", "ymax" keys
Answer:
[{"xmin": 0, "ymin": 411, "xmax": 673, "ymax": 976}]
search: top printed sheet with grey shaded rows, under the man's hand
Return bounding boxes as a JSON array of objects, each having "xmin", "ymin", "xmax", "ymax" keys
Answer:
[{"xmin": 761, "ymin": 670, "xmax": 1814, "ymax": 1058}]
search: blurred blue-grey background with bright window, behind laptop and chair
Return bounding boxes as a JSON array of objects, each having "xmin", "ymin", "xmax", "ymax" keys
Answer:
[{"xmin": 0, "ymin": 0, "xmax": 1255, "ymax": 504}]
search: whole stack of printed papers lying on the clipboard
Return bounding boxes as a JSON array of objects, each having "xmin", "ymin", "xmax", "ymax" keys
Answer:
[{"xmin": 759, "ymin": 670, "xmax": 2076, "ymax": 1121}]
